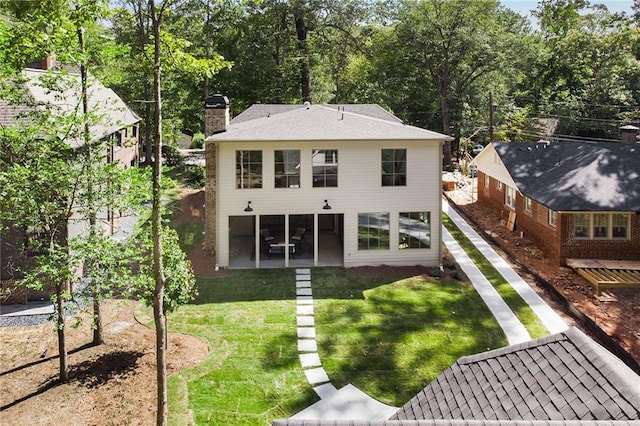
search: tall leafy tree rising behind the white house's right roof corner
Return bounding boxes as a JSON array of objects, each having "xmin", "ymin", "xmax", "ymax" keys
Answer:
[{"xmin": 396, "ymin": 0, "xmax": 524, "ymax": 165}]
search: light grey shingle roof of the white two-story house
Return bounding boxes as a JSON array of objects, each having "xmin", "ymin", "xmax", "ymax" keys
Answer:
[{"xmin": 207, "ymin": 105, "xmax": 451, "ymax": 141}]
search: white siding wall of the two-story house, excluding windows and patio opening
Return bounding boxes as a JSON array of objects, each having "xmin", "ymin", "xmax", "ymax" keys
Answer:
[{"xmin": 217, "ymin": 141, "xmax": 441, "ymax": 266}]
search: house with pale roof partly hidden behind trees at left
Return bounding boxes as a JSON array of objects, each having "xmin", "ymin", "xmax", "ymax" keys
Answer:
[{"xmin": 0, "ymin": 61, "xmax": 140, "ymax": 304}]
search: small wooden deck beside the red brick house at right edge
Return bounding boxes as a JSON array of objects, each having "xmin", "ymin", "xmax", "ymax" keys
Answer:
[{"xmin": 567, "ymin": 259, "xmax": 640, "ymax": 296}]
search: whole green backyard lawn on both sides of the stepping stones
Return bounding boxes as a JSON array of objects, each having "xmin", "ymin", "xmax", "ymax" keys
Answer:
[{"xmin": 159, "ymin": 268, "xmax": 506, "ymax": 425}]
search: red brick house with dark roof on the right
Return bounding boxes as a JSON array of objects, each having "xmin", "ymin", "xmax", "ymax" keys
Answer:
[{"xmin": 472, "ymin": 139, "xmax": 640, "ymax": 265}]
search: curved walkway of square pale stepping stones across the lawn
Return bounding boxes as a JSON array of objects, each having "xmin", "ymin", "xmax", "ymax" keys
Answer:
[{"xmin": 296, "ymin": 269, "xmax": 337, "ymax": 399}]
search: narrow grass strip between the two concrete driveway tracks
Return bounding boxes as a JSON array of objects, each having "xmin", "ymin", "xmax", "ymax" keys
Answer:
[{"xmin": 442, "ymin": 214, "xmax": 549, "ymax": 339}]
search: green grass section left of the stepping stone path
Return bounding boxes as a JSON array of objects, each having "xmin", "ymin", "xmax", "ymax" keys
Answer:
[{"xmin": 169, "ymin": 270, "xmax": 317, "ymax": 425}]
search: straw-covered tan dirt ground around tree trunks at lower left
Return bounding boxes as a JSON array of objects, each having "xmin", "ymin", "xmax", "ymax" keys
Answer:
[{"xmin": 0, "ymin": 301, "xmax": 208, "ymax": 425}]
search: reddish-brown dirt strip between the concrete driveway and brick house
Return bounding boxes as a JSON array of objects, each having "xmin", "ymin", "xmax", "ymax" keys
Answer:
[{"xmin": 446, "ymin": 181, "xmax": 640, "ymax": 363}]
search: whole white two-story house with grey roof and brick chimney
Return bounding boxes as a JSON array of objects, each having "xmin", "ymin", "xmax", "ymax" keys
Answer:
[{"xmin": 205, "ymin": 95, "xmax": 450, "ymax": 268}]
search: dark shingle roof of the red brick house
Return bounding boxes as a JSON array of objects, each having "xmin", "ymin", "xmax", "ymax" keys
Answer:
[{"xmin": 493, "ymin": 142, "xmax": 640, "ymax": 211}]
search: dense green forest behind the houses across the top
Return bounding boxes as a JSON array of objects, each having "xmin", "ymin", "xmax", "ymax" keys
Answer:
[{"xmin": 1, "ymin": 0, "xmax": 640, "ymax": 164}]
